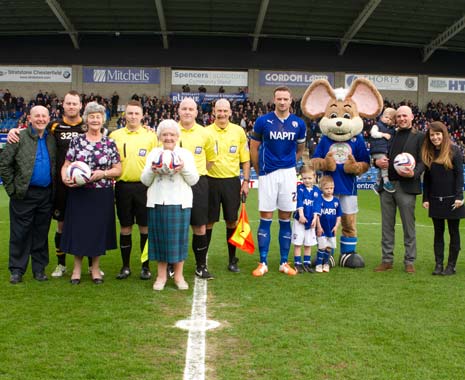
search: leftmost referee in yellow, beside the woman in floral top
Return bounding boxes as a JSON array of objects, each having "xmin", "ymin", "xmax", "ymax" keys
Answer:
[{"xmin": 110, "ymin": 100, "xmax": 158, "ymax": 280}]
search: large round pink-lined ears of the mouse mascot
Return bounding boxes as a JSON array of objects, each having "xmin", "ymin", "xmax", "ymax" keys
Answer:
[{"xmin": 301, "ymin": 78, "xmax": 383, "ymax": 119}]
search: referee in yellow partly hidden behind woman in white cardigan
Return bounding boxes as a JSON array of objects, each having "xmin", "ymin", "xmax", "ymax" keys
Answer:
[{"xmin": 178, "ymin": 98, "xmax": 216, "ymax": 280}]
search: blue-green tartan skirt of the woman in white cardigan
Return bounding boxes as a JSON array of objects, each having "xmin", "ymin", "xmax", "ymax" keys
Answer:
[{"xmin": 148, "ymin": 205, "xmax": 191, "ymax": 263}]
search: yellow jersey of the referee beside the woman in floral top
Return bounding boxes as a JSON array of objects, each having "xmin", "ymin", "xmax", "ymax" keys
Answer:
[{"xmin": 110, "ymin": 126, "xmax": 158, "ymax": 182}]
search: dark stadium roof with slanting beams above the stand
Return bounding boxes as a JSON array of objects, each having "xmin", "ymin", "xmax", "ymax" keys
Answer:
[{"xmin": 0, "ymin": 0, "xmax": 465, "ymax": 62}]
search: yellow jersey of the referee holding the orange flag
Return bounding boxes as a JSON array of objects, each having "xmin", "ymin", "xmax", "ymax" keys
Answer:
[{"xmin": 207, "ymin": 123, "xmax": 250, "ymax": 178}]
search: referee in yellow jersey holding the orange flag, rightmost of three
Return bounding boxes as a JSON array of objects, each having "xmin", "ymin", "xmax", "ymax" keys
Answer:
[{"xmin": 207, "ymin": 99, "xmax": 250, "ymax": 273}]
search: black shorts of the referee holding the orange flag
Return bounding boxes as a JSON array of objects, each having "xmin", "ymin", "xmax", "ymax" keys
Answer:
[{"xmin": 208, "ymin": 177, "xmax": 241, "ymax": 223}]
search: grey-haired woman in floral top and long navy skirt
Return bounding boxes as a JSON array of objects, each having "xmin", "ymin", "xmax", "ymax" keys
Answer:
[{"xmin": 61, "ymin": 102, "xmax": 121, "ymax": 285}]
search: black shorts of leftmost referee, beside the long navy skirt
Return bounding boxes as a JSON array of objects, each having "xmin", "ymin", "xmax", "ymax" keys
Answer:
[{"xmin": 115, "ymin": 181, "xmax": 148, "ymax": 227}]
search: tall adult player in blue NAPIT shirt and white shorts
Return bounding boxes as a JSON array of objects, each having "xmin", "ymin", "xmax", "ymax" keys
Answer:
[{"xmin": 250, "ymin": 86, "xmax": 307, "ymax": 277}]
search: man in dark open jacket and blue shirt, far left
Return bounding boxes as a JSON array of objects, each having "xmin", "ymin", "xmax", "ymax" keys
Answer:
[{"xmin": 0, "ymin": 106, "xmax": 56, "ymax": 284}]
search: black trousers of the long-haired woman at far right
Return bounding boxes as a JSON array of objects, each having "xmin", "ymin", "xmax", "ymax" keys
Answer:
[{"xmin": 432, "ymin": 218, "xmax": 460, "ymax": 265}]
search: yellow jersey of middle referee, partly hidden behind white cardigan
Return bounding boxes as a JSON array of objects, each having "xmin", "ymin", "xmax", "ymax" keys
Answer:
[{"xmin": 179, "ymin": 123, "xmax": 217, "ymax": 175}]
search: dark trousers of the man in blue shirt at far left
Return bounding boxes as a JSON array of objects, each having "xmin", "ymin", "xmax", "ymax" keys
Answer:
[{"xmin": 8, "ymin": 186, "xmax": 52, "ymax": 274}]
